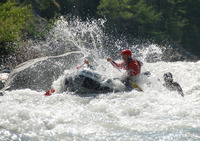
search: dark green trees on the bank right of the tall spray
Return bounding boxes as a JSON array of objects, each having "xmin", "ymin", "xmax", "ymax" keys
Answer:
[{"xmin": 98, "ymin": 0, "xmax": 200, "ymax": 55}]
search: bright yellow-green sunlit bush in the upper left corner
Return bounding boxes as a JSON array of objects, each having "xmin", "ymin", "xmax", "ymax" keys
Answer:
[{"xmin": 0, "ymin": 1, "xmax": 32, "ymax": 54}]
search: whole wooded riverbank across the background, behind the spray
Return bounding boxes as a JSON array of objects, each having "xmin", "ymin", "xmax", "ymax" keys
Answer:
[{"xmin": 0, "ymin": 0, "xmax": 200, "ymax": 68}]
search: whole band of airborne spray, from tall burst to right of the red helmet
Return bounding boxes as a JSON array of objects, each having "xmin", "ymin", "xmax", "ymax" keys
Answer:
[{"xmin": 35, "ymin": 15, "xmax": 162, "ymax": 62}]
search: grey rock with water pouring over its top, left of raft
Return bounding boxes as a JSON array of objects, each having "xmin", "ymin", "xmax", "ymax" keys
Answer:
[{"xmin": 2, "ymin": 51, "xmax": 83, "ymax": 91}]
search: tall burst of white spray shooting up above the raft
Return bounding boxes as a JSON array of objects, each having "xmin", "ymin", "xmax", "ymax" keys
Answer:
[{"xmin": 46, "ymin": 16, "xmax": 106, "ymax": 57}]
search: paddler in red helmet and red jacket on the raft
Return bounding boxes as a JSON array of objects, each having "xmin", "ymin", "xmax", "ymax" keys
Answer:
[{"xmin": 107, "ymin": 49, "xmax": 143, "ymax": 77}]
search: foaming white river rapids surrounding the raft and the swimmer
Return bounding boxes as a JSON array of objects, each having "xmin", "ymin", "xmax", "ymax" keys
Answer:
[{"xmin": 0, "ymin": 17, "xmax": 200, "ymax": 141}]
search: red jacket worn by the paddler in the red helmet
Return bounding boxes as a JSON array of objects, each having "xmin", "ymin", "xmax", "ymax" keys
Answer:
[{"xmin": 113, "ymin": 58, "xmax": 143, "ymax": 76}]
